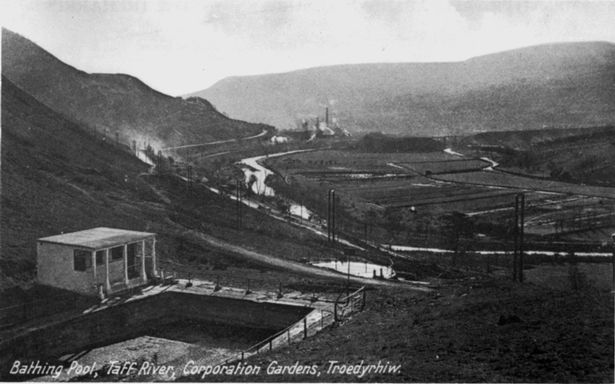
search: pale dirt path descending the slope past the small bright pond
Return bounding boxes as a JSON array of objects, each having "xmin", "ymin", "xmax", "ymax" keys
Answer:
[{"xmin": 190, "ymin": 231, "xmax": 431, "ymax": 292}]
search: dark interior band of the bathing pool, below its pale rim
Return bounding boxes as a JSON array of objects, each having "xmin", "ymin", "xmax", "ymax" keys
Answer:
[{"xmin": 0, "ymin": 292, "xmax": 312, "ymax": 380}]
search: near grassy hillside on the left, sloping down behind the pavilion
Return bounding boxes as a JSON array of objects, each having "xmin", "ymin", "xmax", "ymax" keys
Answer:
[{"xmin": 0, "ymin": 78, "xmax": 394, "ymax": 292}]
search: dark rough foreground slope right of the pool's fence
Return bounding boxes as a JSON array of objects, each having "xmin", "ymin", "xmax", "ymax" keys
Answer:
[{"xmin": 180, "ymin": 278, "xmax": 613, "ymax": 383}]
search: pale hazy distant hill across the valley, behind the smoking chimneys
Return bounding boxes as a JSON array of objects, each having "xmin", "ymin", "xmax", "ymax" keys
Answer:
[{"xmin": 193, "ymin": 42, "xmax": 615, "ymax": 135}]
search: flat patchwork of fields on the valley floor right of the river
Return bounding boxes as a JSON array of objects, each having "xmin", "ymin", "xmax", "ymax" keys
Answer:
[{"xmin": 266, "ymin": 150, "xmax": 615, "ymax": 242}]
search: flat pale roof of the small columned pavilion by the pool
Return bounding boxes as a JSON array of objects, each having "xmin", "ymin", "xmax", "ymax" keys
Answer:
[{"xmin": 38, "ymin": 227, "xmax": 156, "ymax": 250}]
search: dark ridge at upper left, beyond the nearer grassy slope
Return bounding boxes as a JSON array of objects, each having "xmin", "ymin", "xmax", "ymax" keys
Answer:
[{"xmin": 2, "ymin": 29, "xmax": 266, "ymax": 147}]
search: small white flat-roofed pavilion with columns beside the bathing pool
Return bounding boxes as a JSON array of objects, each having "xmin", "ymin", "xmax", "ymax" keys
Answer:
[{"xmin": 36, "ymin": 227, "xmax": 157, "ymax": 296}]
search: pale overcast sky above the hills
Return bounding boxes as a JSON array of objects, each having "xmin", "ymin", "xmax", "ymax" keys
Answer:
[{"xmin": 0, "ymin": 0, "xmax": 615, "ymax": 95}]
